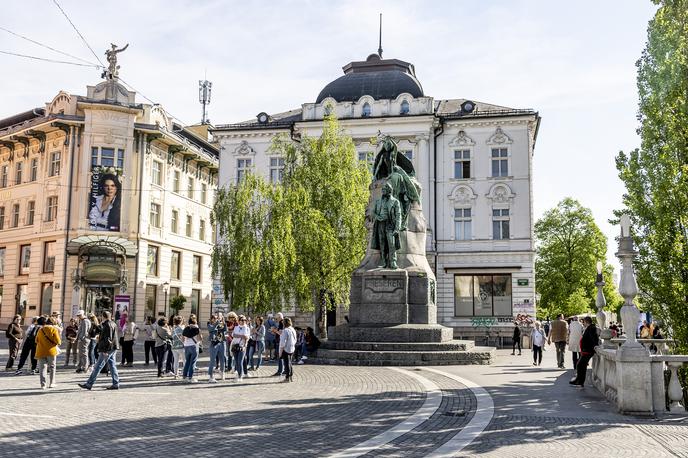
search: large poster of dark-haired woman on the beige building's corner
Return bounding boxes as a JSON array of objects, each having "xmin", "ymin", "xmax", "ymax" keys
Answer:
[{"xmin": 88, "ymin": 165, "xmax": 122, "ymax": 232}]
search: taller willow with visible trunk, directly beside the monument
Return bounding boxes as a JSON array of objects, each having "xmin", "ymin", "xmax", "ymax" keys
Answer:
[{"xmin": 272, "ymin": 117, "xmax": 371, "ymax": 335}]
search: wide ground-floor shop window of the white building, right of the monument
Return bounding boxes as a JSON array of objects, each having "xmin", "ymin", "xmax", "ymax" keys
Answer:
[{"xmin": 454, "ymin": 274, "xmax": 512, "ymax": 316}]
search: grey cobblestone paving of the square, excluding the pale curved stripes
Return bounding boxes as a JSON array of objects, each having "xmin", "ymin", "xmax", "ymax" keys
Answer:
[{"xmin": 0, "ymin": 341, "xmax": 688, "ymax": 458}]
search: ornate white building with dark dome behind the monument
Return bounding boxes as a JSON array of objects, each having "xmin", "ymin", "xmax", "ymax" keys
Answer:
[{"xmin": 213, "ymin": 54, "xmax": 540, "ymax": 343}]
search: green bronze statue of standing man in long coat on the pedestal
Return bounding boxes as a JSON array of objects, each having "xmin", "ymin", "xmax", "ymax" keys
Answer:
[{"xmin": 371, "ymin": 182, "xmax": 401, "ymax": 269}]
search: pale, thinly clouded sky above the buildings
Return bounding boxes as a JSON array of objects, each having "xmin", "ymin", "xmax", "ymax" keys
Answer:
[{"xmin": 0, "ymin": 0, "xmax": 657, "ymax": 267}]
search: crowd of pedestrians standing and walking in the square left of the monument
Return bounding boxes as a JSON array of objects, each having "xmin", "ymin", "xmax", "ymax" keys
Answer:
[{"xmin": 6, "ymin": 310, "xmax": 320, "ymax": 390}]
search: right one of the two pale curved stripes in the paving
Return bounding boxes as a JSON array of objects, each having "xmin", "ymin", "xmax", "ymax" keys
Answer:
[{"xmin": 424, "ymin": 368, "xmax": 494, "ymax": 458}]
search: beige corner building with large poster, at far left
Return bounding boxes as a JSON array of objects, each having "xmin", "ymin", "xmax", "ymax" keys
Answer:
[{"xmin": 0, "ymin": 77, "xmax": 218, "ymax": 323}]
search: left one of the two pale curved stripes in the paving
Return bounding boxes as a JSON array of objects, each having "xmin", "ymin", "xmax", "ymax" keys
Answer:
[{"xmin": 330, "ymin": 367, "xmax": 442, "ymax": 458}]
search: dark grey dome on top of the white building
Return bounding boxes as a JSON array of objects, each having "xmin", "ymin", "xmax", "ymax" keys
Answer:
[{"xmin": 315, "ymin": 54, "xmax": 424, "ymax": 103}]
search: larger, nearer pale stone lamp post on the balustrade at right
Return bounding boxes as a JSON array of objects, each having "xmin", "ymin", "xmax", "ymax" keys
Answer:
[{"xmin": 616, "ymin": 214, "xmax": 647, "ymax": 353}]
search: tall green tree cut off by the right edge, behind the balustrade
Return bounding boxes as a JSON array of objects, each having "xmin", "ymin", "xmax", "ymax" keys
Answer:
[{"xmin": 616, "ymin": 0, "xmax": 688, "ymax": 351}]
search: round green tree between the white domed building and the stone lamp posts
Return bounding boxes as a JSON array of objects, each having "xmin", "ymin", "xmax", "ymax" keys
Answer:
[{"xmin": 535, "ymin": 197, "xmax": 619, "ymax": 318}]
